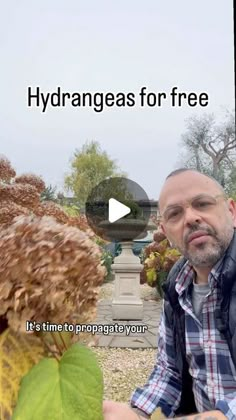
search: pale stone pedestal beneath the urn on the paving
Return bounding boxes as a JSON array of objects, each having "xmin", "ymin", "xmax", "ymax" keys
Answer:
[{"xmin": 112, "ymin": 242, "xmax": 143, "ymax": 320}]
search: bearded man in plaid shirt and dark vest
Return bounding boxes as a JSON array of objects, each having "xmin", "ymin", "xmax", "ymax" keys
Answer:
[{"xmin": 104, "ymin": 169, "xmax": 236, "ymax": 420}]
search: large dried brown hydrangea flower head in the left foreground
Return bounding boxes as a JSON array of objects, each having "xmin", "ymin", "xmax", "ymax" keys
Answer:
[{"xmin": 0, "ymin": 216, "xmax": 105, "ymax": 331}]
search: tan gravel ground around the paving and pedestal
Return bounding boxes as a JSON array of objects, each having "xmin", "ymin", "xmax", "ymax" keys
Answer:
[{"xmin": 92, "ymin": 282, "xmax": 159, "ymax": 402}]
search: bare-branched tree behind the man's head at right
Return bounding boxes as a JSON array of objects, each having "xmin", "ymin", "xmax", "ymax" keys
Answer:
[{"xmin": 180, "ymin": 112, "xmax": 236, "ymax": 188}]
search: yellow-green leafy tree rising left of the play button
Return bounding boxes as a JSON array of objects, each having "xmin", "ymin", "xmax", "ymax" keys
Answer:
[{"xmin": 65, "ymin": 141, "xmax": 126, "ymax": 207}]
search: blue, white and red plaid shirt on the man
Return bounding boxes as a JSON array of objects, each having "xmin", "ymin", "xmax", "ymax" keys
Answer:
[{"xmin": 130, "ymin": 259, "xmax": 236, "ymax": 420}]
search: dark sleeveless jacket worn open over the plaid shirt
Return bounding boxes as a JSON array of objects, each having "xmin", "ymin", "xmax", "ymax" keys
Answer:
[{"xmin": 163, "ymin": 229, "xmax": 236, "ymax": 415}]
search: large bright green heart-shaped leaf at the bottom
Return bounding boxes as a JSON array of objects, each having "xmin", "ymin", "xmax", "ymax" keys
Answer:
[{"xmin": 12, "ymin": 343, "xmax": 103, "ymax": 420}]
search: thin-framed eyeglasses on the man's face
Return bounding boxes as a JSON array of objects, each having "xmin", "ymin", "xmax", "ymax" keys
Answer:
[{"xmin": 161, "ymin": 194, "xmax": 226, "ymax": 224}]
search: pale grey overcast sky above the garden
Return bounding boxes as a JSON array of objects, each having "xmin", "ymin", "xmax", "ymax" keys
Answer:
[{"xmin": 0, "ymin": 0, "xmax": 234, "ymax": 198}]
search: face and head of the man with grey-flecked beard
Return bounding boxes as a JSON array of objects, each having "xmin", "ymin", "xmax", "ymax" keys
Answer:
[{"xmin": 159, "ymin": 171, "xmax": 236, "ymax": 267}]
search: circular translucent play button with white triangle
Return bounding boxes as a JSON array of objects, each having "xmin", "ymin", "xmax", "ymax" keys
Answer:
[{"xmin": 86, "ymin": 177, "xmax": 154, "ymax": 241}]
